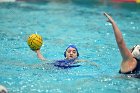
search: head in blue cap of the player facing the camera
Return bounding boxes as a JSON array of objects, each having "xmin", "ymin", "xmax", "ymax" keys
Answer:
[{"xmin": 64, "ymin": 45, "xmax": 79, "ymax": 59}]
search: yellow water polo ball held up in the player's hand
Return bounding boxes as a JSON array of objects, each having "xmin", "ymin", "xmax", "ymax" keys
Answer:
[{"xmin": 27, "ymin": 34, "xmax": 43, "ymax": 51}]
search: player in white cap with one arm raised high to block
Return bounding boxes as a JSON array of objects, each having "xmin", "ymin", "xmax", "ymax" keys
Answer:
[{"xmin": 104, "ymin": 13, "xmax": 140, "ymax": 78}]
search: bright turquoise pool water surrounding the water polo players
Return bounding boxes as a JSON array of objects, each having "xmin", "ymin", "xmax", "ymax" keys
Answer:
[{"xmin": 0, "ymin": 0, "xmax": 140, "ymax": 93}]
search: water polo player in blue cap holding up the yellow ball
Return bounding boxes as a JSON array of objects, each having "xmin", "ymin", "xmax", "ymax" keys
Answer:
[{"xmin": 36, "ymin": 45, "xmax": 83, "ymax": 68}]
